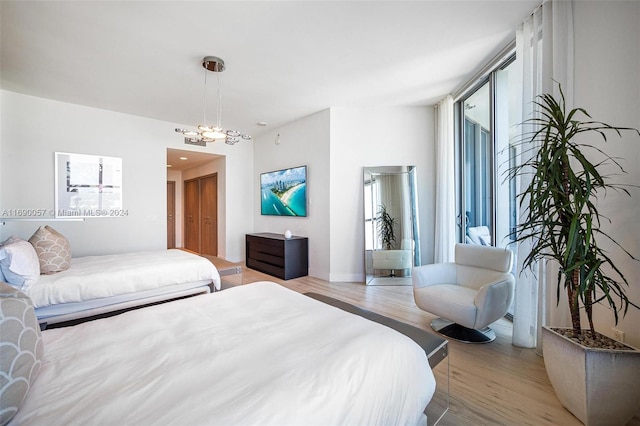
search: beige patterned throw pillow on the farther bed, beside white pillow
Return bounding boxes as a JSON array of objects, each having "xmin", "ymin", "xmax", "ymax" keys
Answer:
[{"xmin": 29, "ymin": 225, "xmax": 71, "ymax": 274}]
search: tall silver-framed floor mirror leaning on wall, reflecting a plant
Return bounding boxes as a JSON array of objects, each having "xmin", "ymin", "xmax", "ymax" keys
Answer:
[{"xmin": 364, "ymin": 166, "xmax": 420, "ymax": 285}]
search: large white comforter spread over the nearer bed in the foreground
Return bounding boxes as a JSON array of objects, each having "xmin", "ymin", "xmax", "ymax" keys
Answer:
[{"xmin": 12, "ymin": 282, "xmax": 435, "ymax": 425}]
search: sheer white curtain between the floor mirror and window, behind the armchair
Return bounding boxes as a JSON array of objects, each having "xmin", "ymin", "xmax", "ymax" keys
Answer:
[{"xmin": 434, "ymin": 95, "xmax": 456, "ymax": 263}]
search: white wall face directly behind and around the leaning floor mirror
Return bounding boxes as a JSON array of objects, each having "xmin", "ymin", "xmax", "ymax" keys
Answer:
[{"xmin": 330, "ymin": 107, "xmax": 435, "ymax": 282}]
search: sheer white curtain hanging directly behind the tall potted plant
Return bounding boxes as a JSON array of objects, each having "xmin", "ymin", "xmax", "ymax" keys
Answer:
[{"xmin": 513, "ymin": 0, "xmax": 574, "ymax": 350}]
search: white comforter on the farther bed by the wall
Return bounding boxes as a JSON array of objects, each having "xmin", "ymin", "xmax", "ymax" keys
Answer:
[{"xmin": 27, "ymin": 250, "xmax": 220, "ymax": 308}]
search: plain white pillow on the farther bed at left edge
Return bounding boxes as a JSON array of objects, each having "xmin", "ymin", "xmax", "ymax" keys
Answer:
[{"xmin": 0, "ymin": 236, "xmax": 40, "ymax": 291}]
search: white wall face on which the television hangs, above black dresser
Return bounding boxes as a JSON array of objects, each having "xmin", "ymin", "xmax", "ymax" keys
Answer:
[{"xmin": 253, "ymin": 110, "xmax": 333, "ymax": 280}]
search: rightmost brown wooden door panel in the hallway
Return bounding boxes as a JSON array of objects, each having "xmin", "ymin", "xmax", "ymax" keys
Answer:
[{"xmin": 200, "ymin": 175, "xmax": 218, "ymax": 256}]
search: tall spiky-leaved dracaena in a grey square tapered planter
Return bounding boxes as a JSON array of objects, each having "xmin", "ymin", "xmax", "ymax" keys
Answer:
[{"xmin": 508, "ymin": 86, "xmax": 640, "ymax": 425}]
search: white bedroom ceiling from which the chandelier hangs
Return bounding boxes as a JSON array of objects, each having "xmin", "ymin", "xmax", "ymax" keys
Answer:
[{"xmin": 0, "ymin": 0, "xmax": 540, "ymax": 140}]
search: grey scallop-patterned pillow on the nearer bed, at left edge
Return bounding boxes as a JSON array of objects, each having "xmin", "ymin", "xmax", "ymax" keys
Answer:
[{"xmin": 0, "ymin": 282, "xmax": 44, "ymax": 425}]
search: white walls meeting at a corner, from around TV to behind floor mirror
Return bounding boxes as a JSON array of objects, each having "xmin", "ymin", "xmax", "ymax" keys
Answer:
[{"xmin": 254, "ymin": 107, "xmax": 434, "ymax": 282}]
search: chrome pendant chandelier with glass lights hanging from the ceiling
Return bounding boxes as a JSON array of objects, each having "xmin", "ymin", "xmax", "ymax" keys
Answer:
[{"xmin": 176, "ymin": 56, "xmax": 251, "ymax": 146}]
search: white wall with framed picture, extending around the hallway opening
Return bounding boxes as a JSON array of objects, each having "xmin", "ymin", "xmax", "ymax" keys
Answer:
[{"xmin": 0, "ymin": 91, "xmax": 253, "ymax": 260}]
